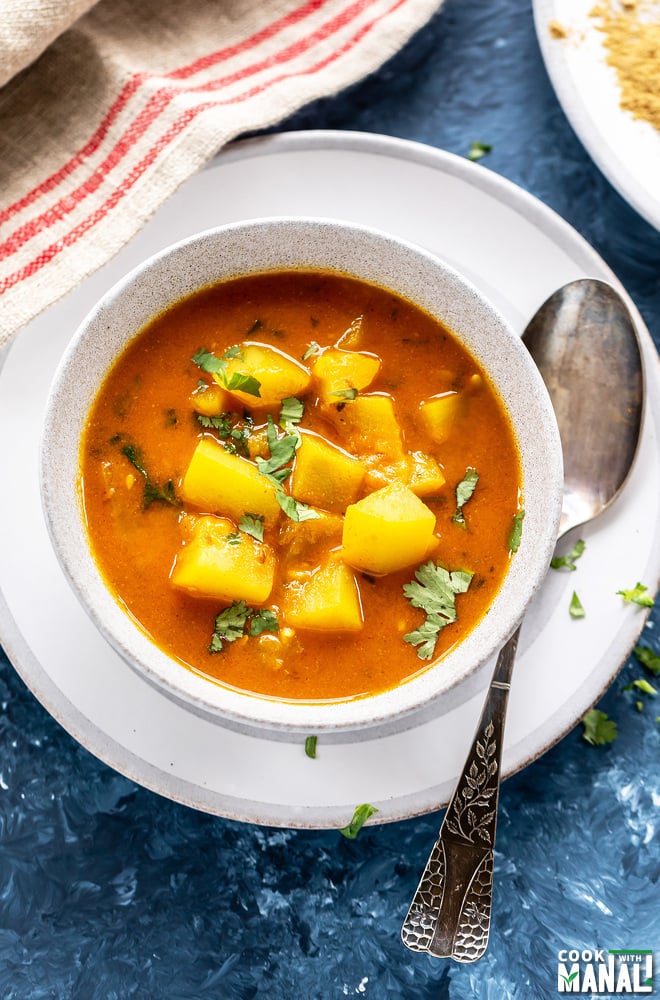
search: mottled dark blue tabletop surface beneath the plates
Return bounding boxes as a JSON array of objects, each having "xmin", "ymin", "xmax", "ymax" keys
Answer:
[{"xmin": 0, "ymin": 0, "xmax": 660, "ymax": 1000}]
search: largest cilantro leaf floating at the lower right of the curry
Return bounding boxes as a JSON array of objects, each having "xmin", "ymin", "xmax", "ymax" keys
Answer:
[{"xmin": 403, "ymin": 562, "xmax": 473, "ymax": 660}]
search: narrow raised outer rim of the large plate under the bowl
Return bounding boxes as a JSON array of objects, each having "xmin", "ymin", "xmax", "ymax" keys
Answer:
[{"xmin": 0, "ymin": 130, "xmax": 660, "ymax": 829}]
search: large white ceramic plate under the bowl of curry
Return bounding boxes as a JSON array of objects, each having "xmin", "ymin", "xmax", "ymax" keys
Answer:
[{"xmin": 0, "ymin": 132, "xmax": 660, "ymax": 827}]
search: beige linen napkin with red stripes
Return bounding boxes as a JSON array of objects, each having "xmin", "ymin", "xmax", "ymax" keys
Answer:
[{"xmin": 0, "ymin": 0, "xmax": 442, "ymax": 347}]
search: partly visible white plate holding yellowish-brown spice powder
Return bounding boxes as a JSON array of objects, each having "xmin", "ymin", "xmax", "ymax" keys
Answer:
[{"xmin": 533, "ymin": 0, "xmax": 660, "ymax": 229}]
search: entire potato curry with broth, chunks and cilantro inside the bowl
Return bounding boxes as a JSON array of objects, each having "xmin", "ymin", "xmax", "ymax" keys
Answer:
[{"xmin": 80, "ymin": 271, "xmax": 523, "ymax": 700}]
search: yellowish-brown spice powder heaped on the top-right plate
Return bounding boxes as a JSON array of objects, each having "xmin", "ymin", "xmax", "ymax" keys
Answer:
[{"xmin": 591, "ymin": 0, "xmax": 660, "ymax": 130}]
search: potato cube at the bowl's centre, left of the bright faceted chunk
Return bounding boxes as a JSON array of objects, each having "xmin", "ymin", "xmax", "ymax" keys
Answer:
[{"xmin": 291, "ymin": 431, "xmax": 364, "ymax": 514}]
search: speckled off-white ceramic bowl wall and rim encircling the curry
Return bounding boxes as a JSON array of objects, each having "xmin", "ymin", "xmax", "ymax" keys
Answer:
[{"xmin": 39, "ymin": 216, "xmax": 563, "ymax": 734}]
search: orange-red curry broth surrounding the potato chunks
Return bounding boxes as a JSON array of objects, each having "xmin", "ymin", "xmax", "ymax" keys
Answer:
[{"xmin": 81, "ymin": 272, "xmax": 520, "ymax": 700}]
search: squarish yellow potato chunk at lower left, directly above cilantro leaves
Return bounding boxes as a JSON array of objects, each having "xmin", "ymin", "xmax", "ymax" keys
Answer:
[{"xmin": 170, "ymin": 515, "xmax": 275, "ymax": 604}]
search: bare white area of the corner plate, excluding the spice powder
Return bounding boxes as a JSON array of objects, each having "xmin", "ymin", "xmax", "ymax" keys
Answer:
[{"xmin": 533, "ymin": 0, "xmax": 660, "ymax": 229}]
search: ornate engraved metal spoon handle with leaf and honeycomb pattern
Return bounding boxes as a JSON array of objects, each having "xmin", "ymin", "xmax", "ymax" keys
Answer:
[{"xmin": 401, "ymin": 626, "xmax": 520, "ymax": 962}]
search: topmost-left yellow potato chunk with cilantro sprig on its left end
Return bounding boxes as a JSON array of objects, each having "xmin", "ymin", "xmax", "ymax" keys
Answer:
[{"xmin": 213, "ymin": 344, "xmax": 311, "ymax": 409}]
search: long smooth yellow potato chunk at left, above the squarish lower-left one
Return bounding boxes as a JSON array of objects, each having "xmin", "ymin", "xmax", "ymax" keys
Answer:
[{"xmin": 181, "ymin": 437, "xmax": 280, "ymax": 524}]
